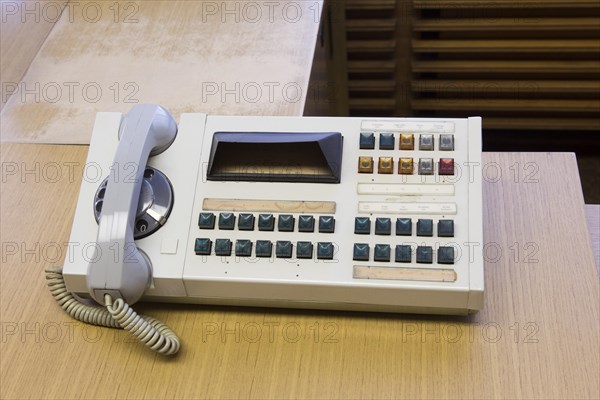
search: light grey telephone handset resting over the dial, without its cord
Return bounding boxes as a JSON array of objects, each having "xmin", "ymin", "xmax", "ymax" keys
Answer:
[{"xmin": 87, "ymin": 104, "xmax": 177, "ymax": 304}]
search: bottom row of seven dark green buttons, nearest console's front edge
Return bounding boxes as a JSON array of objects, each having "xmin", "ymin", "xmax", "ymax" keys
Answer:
[{"xmin": 194, "ymin": 238, "xmax": 334, "ymax": 260}]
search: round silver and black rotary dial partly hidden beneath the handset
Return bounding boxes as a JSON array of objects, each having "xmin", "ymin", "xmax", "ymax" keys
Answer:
[{"xmin": 94, "ymin": 167, "xmax": 173, "ymax": 240}]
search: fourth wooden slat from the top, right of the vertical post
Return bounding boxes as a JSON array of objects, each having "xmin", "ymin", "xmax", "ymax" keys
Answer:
[{"xmin": 413, "ymin": 60, "xmax": 600, "ymax": 74}]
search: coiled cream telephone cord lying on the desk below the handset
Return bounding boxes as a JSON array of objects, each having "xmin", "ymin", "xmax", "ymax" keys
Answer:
[{"xmin": 45, "ymin": 269, "xmax": 181, "ymax": 355}]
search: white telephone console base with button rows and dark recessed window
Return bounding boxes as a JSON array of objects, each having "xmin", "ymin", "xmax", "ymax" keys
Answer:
[{"xmin": 63, "ymin": 113, "xmax": 484, "ymax": 314}]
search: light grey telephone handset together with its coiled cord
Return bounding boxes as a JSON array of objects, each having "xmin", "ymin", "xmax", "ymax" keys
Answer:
[{"xmin": 46, "ymin": 104, "xmax": 180, "ymax": 354}]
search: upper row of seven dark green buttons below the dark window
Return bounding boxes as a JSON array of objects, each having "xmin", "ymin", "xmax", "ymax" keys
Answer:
[{"xmin": 198, "ymin": 212, "xmax": 335, "ymax": 233}]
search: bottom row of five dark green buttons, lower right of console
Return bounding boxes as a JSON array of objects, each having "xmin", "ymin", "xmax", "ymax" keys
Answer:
[{"xmin": 352, "ymin": 243, "xmax": 454, "ymax": 264}]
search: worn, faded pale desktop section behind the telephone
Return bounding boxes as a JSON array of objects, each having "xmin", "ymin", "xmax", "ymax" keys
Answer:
[{"xmin": 1, "ymin": 1, "xmax": 322, "ymax": 144}]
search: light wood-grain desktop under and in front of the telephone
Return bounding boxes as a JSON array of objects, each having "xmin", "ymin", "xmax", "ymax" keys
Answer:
[{"xmin": 0, "ymin": 148, "xmax": 600, "ymax": 399}]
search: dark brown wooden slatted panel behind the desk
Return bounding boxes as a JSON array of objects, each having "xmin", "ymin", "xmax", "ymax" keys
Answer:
[{"xmin": 333, "ymin": 0, "xmax": 600, "ymax": 131}]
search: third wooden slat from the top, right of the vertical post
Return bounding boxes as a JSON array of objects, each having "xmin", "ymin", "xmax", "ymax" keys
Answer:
[{"xmin": 412, "ymin": 39, "xmax": 600, "ymax": 53}]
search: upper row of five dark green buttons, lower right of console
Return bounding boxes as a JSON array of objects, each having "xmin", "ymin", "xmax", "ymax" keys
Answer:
[{"xmin": 354, "ymin": 217, "xmax": 454, "ymax": 237}]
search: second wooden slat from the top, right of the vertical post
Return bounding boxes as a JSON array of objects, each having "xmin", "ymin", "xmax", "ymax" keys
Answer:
[{"xmin": 413, "ymin": 17, "xmax": 600, "ymax": 34}]
